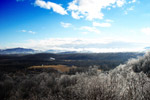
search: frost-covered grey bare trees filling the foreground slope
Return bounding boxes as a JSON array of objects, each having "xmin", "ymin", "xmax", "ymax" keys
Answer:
[{"xmin": 0, "ymin": 53, "xmax": 150, "ymax": 100}]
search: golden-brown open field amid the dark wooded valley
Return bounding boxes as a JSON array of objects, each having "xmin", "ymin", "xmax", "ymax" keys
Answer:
[{"xmin": 29, "ymin": 65, "xmax": 76, "ymax": 72}]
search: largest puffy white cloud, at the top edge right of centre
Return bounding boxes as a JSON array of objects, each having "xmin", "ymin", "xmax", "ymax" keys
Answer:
[{"xmin": 68, "ymin": 0, "xmax": 134, "ymax": 20}]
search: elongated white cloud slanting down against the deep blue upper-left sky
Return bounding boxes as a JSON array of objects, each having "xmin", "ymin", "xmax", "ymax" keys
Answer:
[{"xmin": 35, "ymin": 0, "xmax": 67, "ymax": 15}]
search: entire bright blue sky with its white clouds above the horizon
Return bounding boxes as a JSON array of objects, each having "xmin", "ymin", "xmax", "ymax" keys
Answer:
[{"xmin": 0, "ymin": 0, "xmax": 150, "ymax": 52}]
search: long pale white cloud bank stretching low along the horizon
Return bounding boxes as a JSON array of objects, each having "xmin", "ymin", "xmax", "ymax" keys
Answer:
[{"xmin": 9, "ymin": 38, "xmax": 149, "ymax": 52}]
